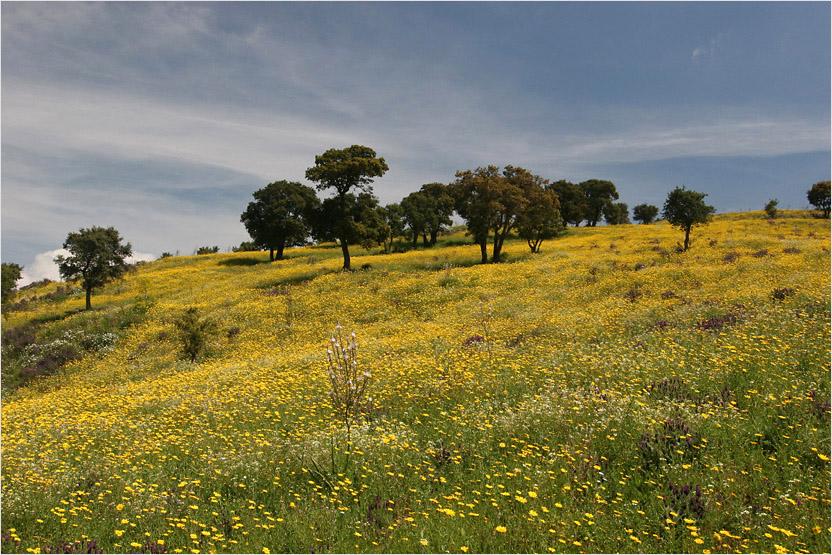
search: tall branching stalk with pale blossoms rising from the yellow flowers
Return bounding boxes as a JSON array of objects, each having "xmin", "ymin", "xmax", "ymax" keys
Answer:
[{"xmin": 326, "ymin": 324, "xmax": 372, "ymax": 458}]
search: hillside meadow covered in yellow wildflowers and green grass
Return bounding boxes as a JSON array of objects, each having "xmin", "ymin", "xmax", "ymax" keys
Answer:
[{"xmin": 2, "ymin": 214, "xmax": 830, "ymax": 553}]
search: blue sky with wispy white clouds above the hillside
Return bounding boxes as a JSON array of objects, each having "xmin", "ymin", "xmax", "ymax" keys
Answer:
[{"xmin": 0, "ymin": 1, "xmax": 830, "ymax": 285}]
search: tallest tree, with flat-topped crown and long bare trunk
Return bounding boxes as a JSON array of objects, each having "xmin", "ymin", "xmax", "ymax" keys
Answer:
[{"xmin": 306, "ymin": 145, "xmax": 389, "ymax": 270}]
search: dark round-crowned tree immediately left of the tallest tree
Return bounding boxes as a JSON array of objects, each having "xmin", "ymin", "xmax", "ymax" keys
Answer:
[{"xmin": 240, "ymin": 181, "xmax": 321, "ymax": 261}]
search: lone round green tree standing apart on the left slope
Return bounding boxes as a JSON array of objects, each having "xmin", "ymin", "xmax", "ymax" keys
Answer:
[{"xmin": 55, "ymin": 226, "xmax": 133, "ymax": 310}]
